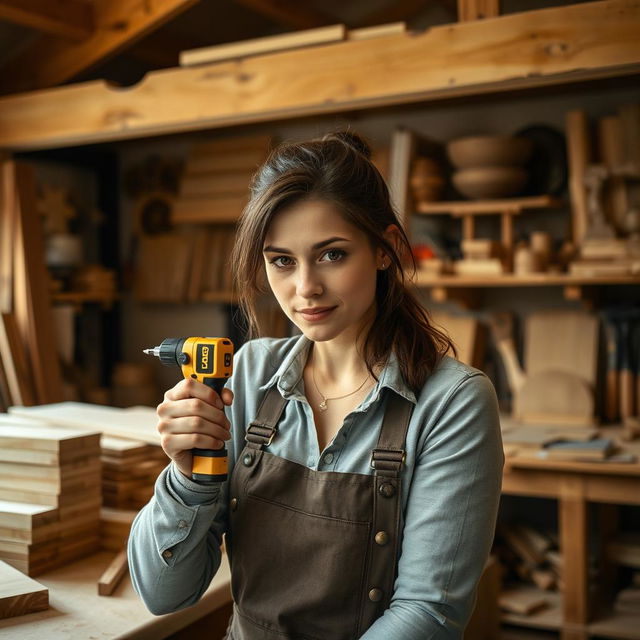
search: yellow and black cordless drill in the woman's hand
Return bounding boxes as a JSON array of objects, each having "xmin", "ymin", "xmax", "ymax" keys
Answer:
[{"xmin": 143, "ymin": 338, "xmax": 233, "ymax": 483}]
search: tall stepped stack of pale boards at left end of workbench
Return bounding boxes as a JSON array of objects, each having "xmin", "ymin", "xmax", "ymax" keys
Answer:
[{"xmin": 0, "ymin": 415, "xmax": 101, "ymax": 576}]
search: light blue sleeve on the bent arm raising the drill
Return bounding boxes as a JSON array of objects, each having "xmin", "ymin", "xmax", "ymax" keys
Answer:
[{"xmin": 128, "ymin": 463, "xmax": 227, "ymax": 615}]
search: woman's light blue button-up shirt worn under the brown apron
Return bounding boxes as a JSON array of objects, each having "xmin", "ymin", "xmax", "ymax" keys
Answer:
[{"xmin": 129, "ymin": 336, "xmax": 503, "ymax": 640}]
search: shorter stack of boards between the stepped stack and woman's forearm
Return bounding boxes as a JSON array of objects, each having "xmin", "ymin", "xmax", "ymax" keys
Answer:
[{"xmin": 102, "ymin": 436, "xmax": 169, "ymax": 509}]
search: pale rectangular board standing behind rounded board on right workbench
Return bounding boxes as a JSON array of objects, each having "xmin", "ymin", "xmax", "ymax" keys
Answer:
[{"xmin": 524, "ymin": 310, "xmax": 598, "ymax": 389}]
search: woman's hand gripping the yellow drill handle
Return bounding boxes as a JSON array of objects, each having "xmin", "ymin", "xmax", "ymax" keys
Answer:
[{"xmin": 157, "ymin": 378, "xmax": 233, "ymax": 478}]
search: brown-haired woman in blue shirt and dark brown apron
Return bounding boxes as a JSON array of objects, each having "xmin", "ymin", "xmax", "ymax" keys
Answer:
[{"xmin": 129, "ymin": 133, "xmax": 503, "ymax": 640}]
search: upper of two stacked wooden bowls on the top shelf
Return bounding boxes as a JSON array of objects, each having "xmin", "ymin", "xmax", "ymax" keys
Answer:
[{"xmin": 447, "ymin": 136, "xmax": 533, "ymax": 169}]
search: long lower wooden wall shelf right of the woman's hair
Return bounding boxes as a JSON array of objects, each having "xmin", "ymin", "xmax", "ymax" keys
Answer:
[{"xmin": 415, "ymin": 269, "xmax": 640, "ymax": 288}]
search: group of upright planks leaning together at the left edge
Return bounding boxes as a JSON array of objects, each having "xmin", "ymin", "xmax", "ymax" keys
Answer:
[{"xmin": 0, "ymin": 160, "xmax": 63, "ymax": 410}]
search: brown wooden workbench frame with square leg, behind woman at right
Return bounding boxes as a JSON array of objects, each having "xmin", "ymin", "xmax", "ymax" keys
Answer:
[{"xmin": 502, "ymin": 443, "xmax": 640, "ymax": 640}]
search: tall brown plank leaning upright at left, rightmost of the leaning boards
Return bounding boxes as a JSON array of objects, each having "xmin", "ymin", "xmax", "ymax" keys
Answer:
[{"xmin": 14, "ymin": 163, "xmax": 62, "ymax": 403}]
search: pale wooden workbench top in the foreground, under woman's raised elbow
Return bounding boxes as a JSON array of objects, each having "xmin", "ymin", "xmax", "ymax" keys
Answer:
[{"xmin": 0, "ymin": 552, "xmax": 231, "ymax": 640}]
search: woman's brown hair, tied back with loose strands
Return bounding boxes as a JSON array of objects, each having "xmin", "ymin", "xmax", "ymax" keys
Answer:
[{"xmin": 231, "ymin": 131, "xmax": 455, "ymax": 391}]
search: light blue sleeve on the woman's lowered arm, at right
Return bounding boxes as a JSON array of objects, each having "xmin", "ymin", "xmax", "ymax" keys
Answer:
[{"xmin": 362, "ymin": 372, "xmax": 504, "ymax": 640}]
